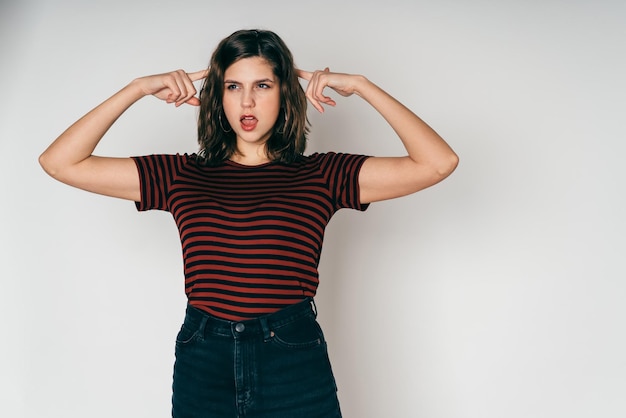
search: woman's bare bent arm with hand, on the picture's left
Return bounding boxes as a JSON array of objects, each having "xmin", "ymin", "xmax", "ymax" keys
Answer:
[{"xmin": 39, "ymin": 70, "xmax": 208, "ymax": 201}]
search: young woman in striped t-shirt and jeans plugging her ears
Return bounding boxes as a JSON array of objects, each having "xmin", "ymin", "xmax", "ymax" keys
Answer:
[{"xmin": 40, "ymin": 30, "xmax": 458, "ymax": 418}]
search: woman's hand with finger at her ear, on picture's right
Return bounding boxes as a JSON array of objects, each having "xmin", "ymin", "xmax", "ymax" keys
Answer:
[{"xmin": 296, "ymin": 67, "xmax": 360, "ymax": 113}]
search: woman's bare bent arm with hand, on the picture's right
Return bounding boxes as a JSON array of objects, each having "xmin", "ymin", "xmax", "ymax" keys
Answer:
[{"xmin": 298, "ymin": 68, "xmax": 459, "ymax": 203}]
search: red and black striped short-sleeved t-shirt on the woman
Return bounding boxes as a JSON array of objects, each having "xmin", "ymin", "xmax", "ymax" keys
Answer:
[{"xmin": 133, "ymin": 153, "xmax": 367, "ymax": 321}]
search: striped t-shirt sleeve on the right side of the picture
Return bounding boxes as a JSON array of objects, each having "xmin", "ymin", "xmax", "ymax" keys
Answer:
[{"xmin": 322, "ymin": 152, "xmax": 369, "ymax": 211}]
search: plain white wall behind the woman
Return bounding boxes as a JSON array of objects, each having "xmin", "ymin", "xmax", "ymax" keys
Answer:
[{"xmin": 0, "ymin": 0, "xmax": 626, "ymax": 418}]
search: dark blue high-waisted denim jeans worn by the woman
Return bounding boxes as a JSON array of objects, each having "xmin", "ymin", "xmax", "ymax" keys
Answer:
[{"xmin": 172, "ymin": 299, "xmax": 341, "ymax": 418}]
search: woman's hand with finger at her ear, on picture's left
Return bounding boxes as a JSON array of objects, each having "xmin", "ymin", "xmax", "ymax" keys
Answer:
[{"xmin": 133, "ymin": 69, "xmax": 209, "ymax": 107}]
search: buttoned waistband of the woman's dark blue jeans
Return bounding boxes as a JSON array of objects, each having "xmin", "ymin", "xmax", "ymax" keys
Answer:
[{"xmin": 185, "ymin": 298, "xmax": 317, "ymax": 339}]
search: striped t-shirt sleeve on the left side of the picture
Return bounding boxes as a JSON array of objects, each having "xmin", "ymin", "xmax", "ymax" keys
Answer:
[{"xmin": 132, "ymin": 154, "xmax": 186, "ymax": 211}]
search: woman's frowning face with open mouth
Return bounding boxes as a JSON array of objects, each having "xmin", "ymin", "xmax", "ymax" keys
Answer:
[{"xmin": 223, "ymin": 57, "xmax": 281, "ymax": 154}]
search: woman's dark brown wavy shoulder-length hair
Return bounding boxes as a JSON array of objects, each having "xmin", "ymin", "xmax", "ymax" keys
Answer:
[{"xmin": 198, "ymin": 29, "xmax": 309, "ymax": 165}]
